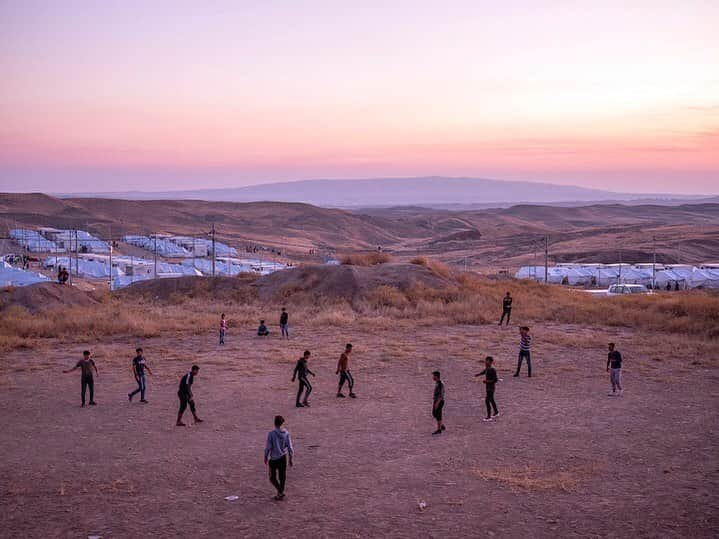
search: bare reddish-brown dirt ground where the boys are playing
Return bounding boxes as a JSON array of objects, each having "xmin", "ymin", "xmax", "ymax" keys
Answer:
[{"xmin": 0, "ymin": 322, "xmax": 719, "ymax": 538}]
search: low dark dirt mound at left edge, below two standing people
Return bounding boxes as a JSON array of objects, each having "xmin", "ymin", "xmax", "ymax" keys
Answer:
[{"xmin": 0, "ymin": 283, "xmax": 97, "ymax": 312}]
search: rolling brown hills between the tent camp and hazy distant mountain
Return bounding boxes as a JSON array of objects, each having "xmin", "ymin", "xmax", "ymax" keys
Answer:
[{"xmin": 0, "ymin": 194, "xmax": 719, "ymax": 271}]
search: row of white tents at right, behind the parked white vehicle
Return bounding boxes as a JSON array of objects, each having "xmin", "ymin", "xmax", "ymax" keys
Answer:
[{"xmin": 515, "ymin": 266, "xmax": 719, "ymax": 289}]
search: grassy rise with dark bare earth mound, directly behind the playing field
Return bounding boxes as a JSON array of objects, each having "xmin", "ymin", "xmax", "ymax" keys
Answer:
[{"xmin": 0, "ymin": 259, "xmax": 719, "ymax": 351}]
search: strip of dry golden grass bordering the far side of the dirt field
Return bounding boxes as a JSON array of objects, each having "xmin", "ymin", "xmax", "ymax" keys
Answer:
[{"xmin": 0, "ymin": 270, "xmax": 719, "ymax": 351}]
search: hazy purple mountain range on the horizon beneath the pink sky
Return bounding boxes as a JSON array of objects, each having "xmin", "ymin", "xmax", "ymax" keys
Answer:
[{"xmin": 57, "ymin": 177, "xmax": 719, "ymax": 209}]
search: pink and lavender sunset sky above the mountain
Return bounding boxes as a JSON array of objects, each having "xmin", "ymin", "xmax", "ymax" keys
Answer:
[{"xmin": 0, "ymin": 0, "xmax": 719, "ymax": 194}]
